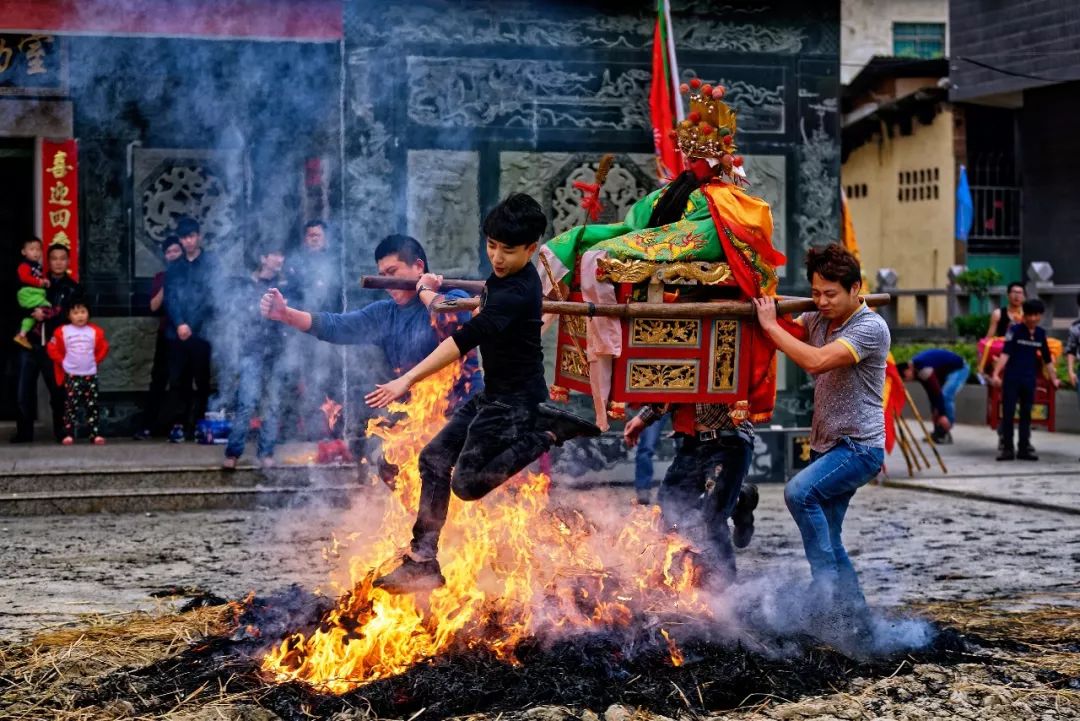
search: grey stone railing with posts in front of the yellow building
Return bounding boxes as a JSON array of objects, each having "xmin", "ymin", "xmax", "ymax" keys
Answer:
[{"xmin": 876, "ymin": 261, "xmax": 1080, "ymax": 339}]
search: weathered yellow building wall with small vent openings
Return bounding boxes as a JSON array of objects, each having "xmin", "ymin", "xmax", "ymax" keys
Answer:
[{"xmin": 840, "ymin": 108, "xmax": 956, "ymax": 326}]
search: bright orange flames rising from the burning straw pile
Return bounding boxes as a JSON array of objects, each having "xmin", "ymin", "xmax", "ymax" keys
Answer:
[{"xmin": 262, "ymin": 368, "xmax": 710, "ymax": 693}]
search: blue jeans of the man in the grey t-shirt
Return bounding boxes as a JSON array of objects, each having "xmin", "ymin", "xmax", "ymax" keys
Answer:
[{"xmin": 784, "ymin": 436, "xmax": 885, "ymax": 604}]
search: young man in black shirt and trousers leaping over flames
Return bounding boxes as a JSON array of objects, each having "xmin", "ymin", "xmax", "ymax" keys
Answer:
[{"xmin": 366, "ymin": 193, "xmax": 600, "ymax": 594}]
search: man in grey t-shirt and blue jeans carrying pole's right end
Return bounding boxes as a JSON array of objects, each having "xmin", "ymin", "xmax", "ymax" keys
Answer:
[{"xmin": 755, "ymin": 244, "xmax": 890, "ymax": 640}]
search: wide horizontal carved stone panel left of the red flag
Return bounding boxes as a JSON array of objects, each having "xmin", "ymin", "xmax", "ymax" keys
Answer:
[{"xmin": 407, "ymin": 56, "xmax": 650, "ymax": 131}]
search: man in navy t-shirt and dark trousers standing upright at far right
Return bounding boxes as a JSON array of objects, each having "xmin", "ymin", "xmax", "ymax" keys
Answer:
[{"xmin": 990, "ymin": 299, "xmax": 1059, "ymax": 461}]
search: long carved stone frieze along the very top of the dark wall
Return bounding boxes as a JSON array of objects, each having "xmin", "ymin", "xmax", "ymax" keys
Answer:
[{"xmin": 350, "ymin": 0, "xmax": 808, "ymax": 54}]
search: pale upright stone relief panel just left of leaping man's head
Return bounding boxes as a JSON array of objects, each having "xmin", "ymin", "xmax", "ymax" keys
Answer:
[{"xmin": 407, "ymin": 150, "xmax": 481, "ymax": 277}]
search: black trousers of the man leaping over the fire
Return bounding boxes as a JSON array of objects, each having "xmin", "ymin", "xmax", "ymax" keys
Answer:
[{"xmin": 411, "ymin": 394, "xmax": 551, "ymax": 558}]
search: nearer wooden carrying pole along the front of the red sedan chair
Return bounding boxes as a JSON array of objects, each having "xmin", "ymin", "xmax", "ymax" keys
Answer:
[{"xmin": 431, "ymin": 293, "xmax": 889, "ymax": 318}]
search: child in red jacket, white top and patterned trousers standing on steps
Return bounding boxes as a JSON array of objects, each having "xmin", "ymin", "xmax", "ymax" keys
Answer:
[{"xmin": 49, "ymin": 297, "xmax": 109, "ymax": 446}]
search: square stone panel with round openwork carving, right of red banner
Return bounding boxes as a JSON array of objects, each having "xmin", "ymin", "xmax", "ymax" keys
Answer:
[{"xmin": 132, "ymin": 148, "xmax": 244, "ymax": 277}]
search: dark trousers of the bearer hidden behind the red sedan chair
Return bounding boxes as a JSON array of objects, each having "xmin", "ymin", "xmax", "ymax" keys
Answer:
[{"xmin": 658, "ymin": 436, "xmax": 754, "ymax": 581}]
